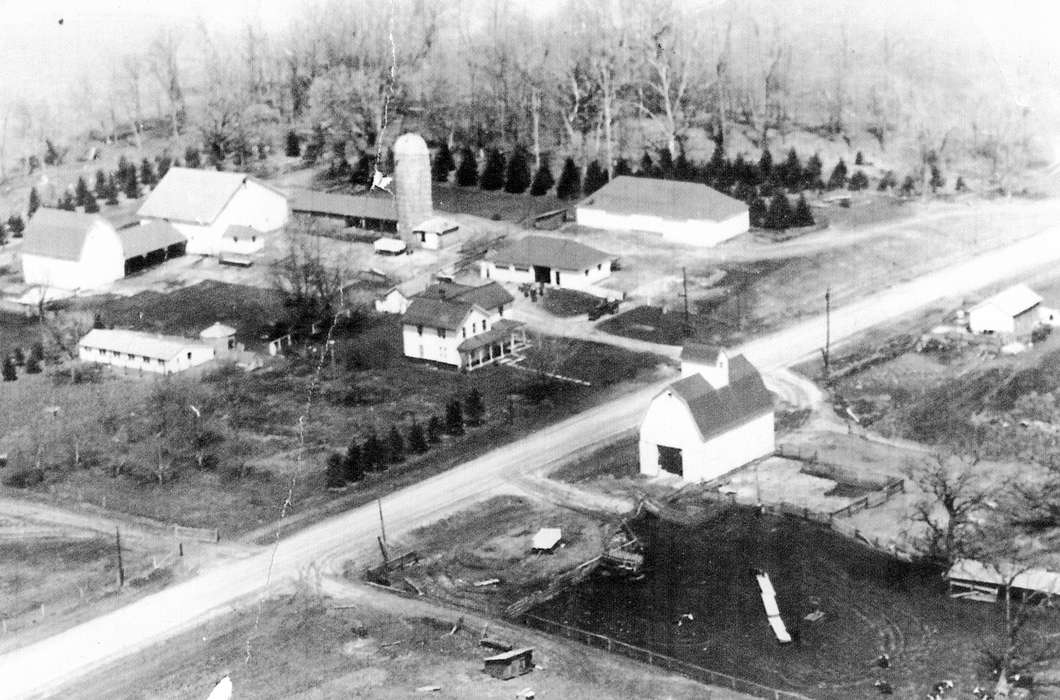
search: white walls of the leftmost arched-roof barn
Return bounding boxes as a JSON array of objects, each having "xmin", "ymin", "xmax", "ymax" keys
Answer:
[{"xmin": 21, "ymin": 222, "xmax": 125, "ymax": 291}]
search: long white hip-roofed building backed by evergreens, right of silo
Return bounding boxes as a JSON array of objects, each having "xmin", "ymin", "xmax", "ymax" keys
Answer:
[{"xmin": 575, "ymin": 175, "xmax": 750, "ymax": 246}]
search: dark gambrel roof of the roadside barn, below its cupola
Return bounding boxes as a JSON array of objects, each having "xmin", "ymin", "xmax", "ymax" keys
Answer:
[{"xmin": 664, "ymin": 355, "xmax": 773, "ymax": 440}]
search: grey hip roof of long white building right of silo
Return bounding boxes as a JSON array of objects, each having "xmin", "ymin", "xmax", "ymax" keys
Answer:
[{"xmin": 578, "ymin": 175, "xmax": 747, "ymax": 222}]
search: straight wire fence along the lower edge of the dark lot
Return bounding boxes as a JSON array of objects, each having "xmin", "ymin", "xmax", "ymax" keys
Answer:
[{"xmin": 518, "ymin": 614, "xmax": 811, "ymax": 700}]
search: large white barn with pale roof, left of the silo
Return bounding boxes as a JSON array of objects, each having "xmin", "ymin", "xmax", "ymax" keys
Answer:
[{"xmin": 137, "ymin": 168, "xmax": 288, "ymax": 256}]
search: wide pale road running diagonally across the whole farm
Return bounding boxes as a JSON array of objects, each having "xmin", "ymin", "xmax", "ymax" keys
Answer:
[{"xmin": 6, "ymin": 221, "xmax": 1060, "ymax": 698}]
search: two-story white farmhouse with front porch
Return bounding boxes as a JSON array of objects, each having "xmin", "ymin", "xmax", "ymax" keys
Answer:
[{"xmin": 402, "ymin": 282, "xmax": 527, "ymax": 369}]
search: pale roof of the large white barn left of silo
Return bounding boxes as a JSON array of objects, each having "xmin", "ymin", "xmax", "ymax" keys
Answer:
[{"xmin": 137, "ymin": 168, "xmax": 279, "ymax": 224}]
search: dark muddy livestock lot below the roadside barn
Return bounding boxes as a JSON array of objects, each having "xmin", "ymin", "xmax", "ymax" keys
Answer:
[{"xmin": 531, "ymin": 508, "xmax": 1060, "ymax": 700}]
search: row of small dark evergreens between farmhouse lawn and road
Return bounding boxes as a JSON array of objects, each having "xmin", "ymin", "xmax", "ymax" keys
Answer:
[{"xmin": 324, "ymin": 388, "xmax": 485, "ymax": 489}]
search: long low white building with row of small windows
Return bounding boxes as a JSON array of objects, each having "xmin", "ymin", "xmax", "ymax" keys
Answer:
[{"xmin": 77, "ymin": 328, "xmax": 216, "ymax": 374}]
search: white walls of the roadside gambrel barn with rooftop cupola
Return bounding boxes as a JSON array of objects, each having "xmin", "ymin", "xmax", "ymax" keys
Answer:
[{"xmin": 639, "ymin": 393, "xmax": 775, "ymax": 482}]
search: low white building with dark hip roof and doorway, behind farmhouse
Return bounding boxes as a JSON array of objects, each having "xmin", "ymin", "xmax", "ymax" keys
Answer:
[{"xmin": 481, "ymin": 235, "xmax": 612, "ymax": 291}]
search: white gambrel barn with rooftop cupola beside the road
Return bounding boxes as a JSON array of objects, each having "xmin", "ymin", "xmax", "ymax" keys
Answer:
[{"xmin": 639, "ymin": 344, "xmax": 776, "ymax": 482}]
